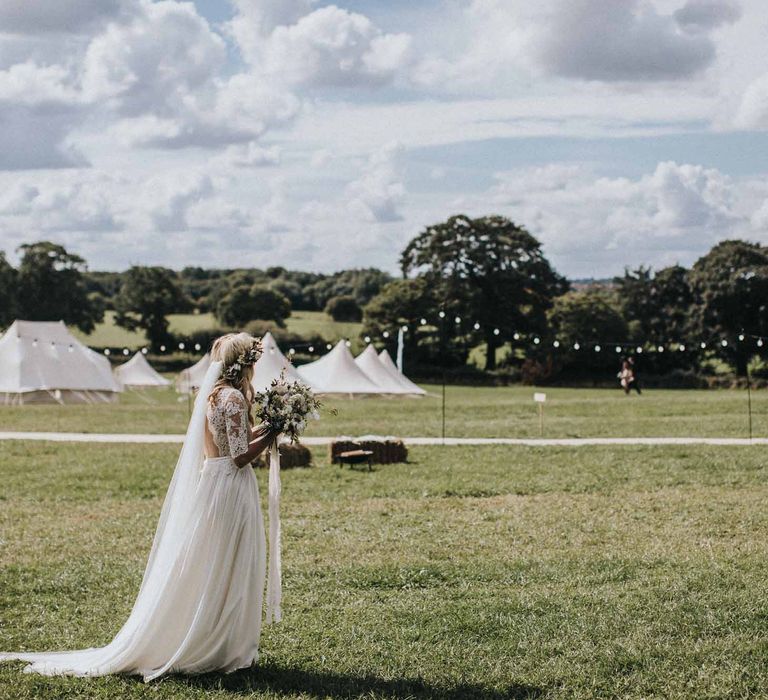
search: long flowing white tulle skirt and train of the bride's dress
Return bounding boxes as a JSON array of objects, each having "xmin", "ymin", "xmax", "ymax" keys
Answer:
[{"xmin": 0, "ymin": 457, "xmax": 266, "ymax": 681}]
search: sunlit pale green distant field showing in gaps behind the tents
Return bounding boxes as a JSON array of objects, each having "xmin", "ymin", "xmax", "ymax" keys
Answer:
[{"xmin": 72, "ymin": 311, "xmax": 362, "ymax": 349}]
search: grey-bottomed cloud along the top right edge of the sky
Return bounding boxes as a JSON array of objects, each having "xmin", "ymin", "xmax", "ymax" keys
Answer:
[{"xmin": 414, "ymin": 0, "xmax": 739, "ymax": 91}]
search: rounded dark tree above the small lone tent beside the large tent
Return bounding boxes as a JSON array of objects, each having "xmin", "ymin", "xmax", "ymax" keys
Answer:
[{"xmin": 115, "ymin": 266, "xmax": 190, "ymax": 349}]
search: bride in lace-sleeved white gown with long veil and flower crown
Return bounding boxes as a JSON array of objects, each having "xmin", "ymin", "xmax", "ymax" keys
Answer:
[{"xmin": 0, "ymin": 333, "xmax": 280, "ymax": 681}]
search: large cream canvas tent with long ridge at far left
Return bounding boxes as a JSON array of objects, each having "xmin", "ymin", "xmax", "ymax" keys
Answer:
[{"xmin": 0, "ymin": 321, "xmax": 121, "ymax": 404}]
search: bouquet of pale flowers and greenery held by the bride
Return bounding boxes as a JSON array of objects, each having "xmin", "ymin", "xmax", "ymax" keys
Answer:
[{"xmin": 254, "ymin": 372, "xmax": 321, "ymax": 442}]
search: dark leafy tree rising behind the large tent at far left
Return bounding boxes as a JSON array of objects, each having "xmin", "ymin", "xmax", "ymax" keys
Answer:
[{"xmin": 16, "ymin": 241, "xmax": 104, "ymax": 333}]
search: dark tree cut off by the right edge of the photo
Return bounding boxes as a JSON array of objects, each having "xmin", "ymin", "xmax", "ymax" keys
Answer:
[{"xmin": 689, "ymin": 240, "xmax": 768, "ymax": 376}]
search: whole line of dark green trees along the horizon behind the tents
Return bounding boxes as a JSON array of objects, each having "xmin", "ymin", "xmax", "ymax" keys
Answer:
[{"xmin": 0, "ymin": 220, "xmax": 768, "ymax": 381}]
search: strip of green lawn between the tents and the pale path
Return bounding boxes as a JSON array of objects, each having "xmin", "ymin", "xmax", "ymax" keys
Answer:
[{"xmin": 0, "ymin": 386, "xmax": 768, "ymax": 437}]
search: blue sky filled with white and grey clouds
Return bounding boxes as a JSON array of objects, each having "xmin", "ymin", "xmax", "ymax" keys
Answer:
[{"xmin": 0, "ymin": 0, "xmax": 768, "ymax": 278}]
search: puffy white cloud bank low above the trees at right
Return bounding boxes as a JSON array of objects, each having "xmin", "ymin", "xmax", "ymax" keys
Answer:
[{"xmin": 474, "ymin": 162, "xmax": 756, "ymax": 276}]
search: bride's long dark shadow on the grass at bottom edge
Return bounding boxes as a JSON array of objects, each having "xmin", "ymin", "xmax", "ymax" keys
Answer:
[{"xmin": 174, "ymin": 663, "xmax": 544, "ymax": 700}]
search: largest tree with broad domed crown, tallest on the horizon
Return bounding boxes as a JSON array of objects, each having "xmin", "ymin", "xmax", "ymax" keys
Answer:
[{"xmin": 401, "ymin": 214, "xmax": 568, "ymax": 369}]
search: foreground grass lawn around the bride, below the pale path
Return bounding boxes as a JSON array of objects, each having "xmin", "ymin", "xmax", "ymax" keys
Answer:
[{"xmin": 0, "ymin": 442, "xmax": 768, "ymax": 700}]
